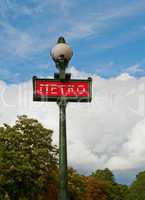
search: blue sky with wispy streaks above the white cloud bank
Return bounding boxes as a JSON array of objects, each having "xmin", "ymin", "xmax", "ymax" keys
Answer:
[{"xmin": 0, "ymin": 0, "xmax": 145, "ymax": 83}]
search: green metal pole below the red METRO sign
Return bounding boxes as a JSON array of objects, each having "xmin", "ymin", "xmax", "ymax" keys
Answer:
[{"xmin": 59, "ymin": 100, "xmax": 68, "ymax": 200}]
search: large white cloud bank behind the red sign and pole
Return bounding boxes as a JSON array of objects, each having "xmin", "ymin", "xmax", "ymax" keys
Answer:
[{"xmin": 0, "ymin": 68, "xmax": 145, "ymax": 172}]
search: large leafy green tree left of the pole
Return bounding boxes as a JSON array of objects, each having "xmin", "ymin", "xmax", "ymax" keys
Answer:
[{"xmin": 0, "ymin": 115, "xmax": 58, "ymax": 200}]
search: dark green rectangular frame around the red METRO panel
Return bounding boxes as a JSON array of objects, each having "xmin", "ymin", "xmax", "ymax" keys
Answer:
[{"xmin": 33, "ymin": 76, "xmax": 92, "ymax": 102}]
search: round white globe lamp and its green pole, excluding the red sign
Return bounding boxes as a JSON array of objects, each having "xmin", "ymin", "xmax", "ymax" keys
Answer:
[{"xmin": 50, "ymin": 37, "xmax": 73, "ymax": 200}]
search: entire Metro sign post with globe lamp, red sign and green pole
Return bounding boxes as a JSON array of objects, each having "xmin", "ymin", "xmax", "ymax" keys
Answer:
[{"xmin": 33, "ymin": 37, "xmax": 92, "ymax": 200}]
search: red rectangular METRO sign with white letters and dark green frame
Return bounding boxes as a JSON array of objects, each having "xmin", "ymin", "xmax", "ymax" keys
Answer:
[{"xmin": 33, "ymin": 77, "xmax": 92, "ymax": 102}]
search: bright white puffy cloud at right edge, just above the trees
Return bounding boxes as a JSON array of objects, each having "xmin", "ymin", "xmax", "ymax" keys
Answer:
[{"xmin": 106, "ymin": 119, "xmax": 145, "ymax": 169}]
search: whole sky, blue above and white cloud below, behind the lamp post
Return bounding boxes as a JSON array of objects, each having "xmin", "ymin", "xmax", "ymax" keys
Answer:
[{"xmin": 0, "ymin": 0, "xmax": 145, "ymax": 182}]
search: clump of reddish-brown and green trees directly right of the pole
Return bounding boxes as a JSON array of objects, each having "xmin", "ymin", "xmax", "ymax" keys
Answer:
[{"xmin": 68, "ymin": 168, "xmax": 128, "ymax": 200}]
